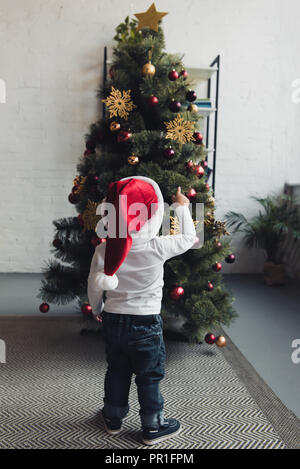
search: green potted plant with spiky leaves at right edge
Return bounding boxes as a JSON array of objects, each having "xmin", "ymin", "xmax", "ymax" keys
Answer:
[{"xmin": 226, "ymin": 195, "xmax": 300, "ymax": 285}]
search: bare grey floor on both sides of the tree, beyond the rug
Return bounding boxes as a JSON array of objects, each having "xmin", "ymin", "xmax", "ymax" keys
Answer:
[{"xmin": 0, "ymin": 274, "xmax": 300, "ymax": 417}]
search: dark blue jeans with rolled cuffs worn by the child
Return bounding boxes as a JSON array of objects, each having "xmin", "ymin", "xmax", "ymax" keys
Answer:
[{"xmin": 102, "ymin": 311, "xmax": 166, "ymax": 428}]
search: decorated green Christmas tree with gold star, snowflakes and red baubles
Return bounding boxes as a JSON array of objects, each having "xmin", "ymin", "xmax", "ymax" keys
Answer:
[{"xmin": 38, "ymin": 4, "xmax": 235, "ymax": 342}]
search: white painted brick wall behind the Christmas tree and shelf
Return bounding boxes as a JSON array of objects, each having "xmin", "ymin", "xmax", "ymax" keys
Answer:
[{"xmin": 0, "ymin": 0, "xmax": 300, "ymax": 272}]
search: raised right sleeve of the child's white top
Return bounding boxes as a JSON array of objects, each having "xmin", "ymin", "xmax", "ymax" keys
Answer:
[{"xmin": 153, "ymin": 205, "xmax": 196, "ymax": 261}]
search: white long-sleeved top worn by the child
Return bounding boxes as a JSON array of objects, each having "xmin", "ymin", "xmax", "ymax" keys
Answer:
[{"xmin": 88, "ymin": 176, "xmax": 196, "ymax": 315}]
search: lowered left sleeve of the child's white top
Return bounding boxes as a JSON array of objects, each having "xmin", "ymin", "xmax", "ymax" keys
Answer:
[{"xmin": 87, "ymin": 243, "xmax": 105, "ymax": 316}]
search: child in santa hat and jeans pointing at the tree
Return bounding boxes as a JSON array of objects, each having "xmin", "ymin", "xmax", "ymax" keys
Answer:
[{"xmin": 88, "ymin": 176, "xmax": 196, "ymax": 445}]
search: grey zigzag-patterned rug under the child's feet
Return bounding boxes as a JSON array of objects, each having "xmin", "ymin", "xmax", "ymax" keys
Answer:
[{"xmin": 0, "ymin": 316, "xmax": 295, "ymax": 449}]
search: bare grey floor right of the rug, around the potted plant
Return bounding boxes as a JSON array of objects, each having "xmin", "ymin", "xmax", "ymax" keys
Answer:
[{"xmin": 224, "ymin": 274, "xmax": 300, "ymax": 417}]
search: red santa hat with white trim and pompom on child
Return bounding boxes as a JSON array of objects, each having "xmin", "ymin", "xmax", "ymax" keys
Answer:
[{"xmin": 95, "ymin": 176, "xmax": 164, "ymax": 290}]
